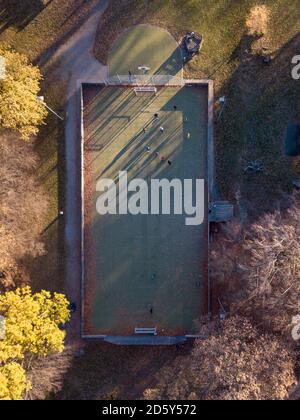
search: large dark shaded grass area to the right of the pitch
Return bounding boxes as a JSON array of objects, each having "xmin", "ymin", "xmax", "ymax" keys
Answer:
[{"xmin": 216, "ymin": 34, "xmax": 300, "ymax": 218}]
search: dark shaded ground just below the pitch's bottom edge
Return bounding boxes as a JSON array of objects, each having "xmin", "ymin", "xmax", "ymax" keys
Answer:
[{"xmin": 55, "ymin": 342, "xmax": 191, "ymax": 400}]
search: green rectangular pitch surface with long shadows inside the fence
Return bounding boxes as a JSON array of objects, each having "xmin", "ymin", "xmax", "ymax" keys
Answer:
[{"xmin": 84, "ymin": 83, "xmax": 208, "ymax": 335}]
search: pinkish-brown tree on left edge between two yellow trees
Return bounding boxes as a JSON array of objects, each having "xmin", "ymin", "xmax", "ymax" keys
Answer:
[{"xmin": 0, "ymin": 133, "xmax": 48, "ymax": 290}]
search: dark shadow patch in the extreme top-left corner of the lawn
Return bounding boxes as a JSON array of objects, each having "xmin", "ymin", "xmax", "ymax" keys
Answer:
[{"xmin": 0, "ymin": 0, "xmax": 52, "ymax": 33}]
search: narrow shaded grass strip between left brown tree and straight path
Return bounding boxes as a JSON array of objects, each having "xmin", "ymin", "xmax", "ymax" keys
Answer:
[{"xmin": 21, "ymin": 103, "xmax": 65, "ymax": 293}]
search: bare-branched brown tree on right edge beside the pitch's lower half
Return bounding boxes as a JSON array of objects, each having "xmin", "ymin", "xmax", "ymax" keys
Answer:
[{"xmin": 211, "ymin": 193, "xmax": 300, "ymax": 339}]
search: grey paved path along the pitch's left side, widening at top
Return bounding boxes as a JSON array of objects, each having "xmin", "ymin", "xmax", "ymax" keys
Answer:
[{"xmin": 53, "ymin": 0, "xmax": 109, "ymax": 342}]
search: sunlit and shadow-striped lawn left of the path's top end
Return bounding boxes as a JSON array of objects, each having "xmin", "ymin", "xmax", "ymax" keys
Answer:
[{"xmin": 0, "ymin": 0, "xmax": 101, "ymax": 63}]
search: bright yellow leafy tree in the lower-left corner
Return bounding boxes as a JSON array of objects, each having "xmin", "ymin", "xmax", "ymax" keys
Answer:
[{"xmin": 0, "ymin": 287, "xmax": 70, "ymax": 399}]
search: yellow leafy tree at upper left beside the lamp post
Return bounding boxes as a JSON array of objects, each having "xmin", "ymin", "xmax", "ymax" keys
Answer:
[{"xmin": 0, "ymin": 46, "xmax": 47, "ymax": 140}]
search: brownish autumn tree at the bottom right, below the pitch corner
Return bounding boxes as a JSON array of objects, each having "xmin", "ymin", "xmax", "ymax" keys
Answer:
[{"xmin": 144, "ymin": 317, "xmax": 296, "ymax": 400}]
